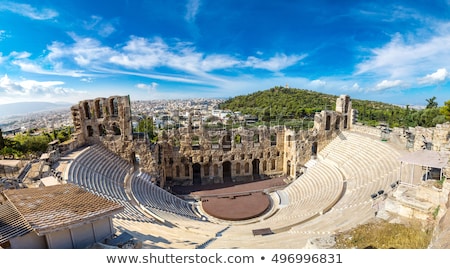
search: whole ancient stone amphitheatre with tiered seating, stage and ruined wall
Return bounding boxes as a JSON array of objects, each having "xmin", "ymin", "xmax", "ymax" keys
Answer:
[{"xmin": 0, "ymin": 95, "xmax": 450, "ymax": 249}]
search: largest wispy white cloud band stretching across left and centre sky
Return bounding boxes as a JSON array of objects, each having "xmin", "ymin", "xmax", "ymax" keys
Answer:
[{"xmin": 12, "ymin": 33, "xmax": 306, "ymax": 85}]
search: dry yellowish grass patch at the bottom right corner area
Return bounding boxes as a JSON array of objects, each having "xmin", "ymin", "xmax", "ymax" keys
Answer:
[{"xmin": 335, "ymin": 221, "xmax": 432, "ymax": 249}]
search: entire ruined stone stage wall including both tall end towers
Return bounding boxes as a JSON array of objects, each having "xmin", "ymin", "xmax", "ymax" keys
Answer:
[{"xmin": 72, "ymin": 95, "xmax": 352, "ymax": 186}]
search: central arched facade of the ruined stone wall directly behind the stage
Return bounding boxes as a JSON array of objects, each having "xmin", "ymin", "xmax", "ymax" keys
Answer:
[{"xmin": 158, "ymin": 126, "xmax": 285, "ymax": 185}]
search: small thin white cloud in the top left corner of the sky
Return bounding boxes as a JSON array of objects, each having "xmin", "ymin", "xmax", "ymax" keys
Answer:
[{"xmin": 0, "ymin": 1, "xmax": 59, "ymax": 20}]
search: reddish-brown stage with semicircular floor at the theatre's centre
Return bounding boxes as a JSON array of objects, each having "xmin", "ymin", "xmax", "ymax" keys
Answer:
[{"xmin": 175, "ymin": 177, "xmax": 287, "ymax": 221}]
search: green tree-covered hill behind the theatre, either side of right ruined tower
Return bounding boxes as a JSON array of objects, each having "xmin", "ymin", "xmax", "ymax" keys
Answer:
[{"xmin": 220, "ymin": 86, "xmax": 450, "ymax": 127}]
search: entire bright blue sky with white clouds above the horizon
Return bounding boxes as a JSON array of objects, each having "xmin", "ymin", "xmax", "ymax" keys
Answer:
[{"xmin": 0, "ymin": 0, "xmax": 450, "ymax": 105}]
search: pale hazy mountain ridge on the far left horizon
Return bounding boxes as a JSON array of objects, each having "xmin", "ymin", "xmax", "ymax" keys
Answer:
[{"xmin": 0, "ymin": 102, "xmax": 72, "ymax": 118}]
